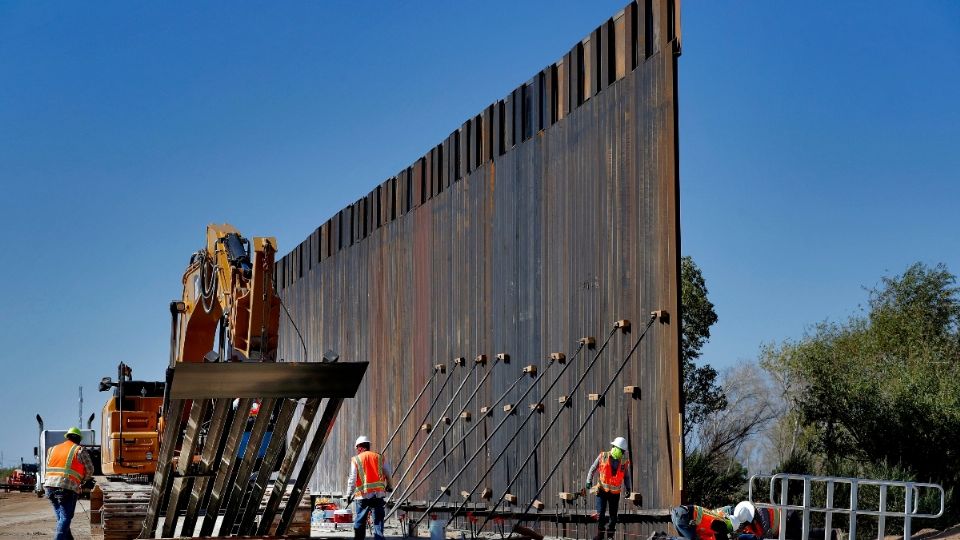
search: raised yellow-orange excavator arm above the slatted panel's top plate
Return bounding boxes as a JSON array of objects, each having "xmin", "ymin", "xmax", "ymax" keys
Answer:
[{"xmin": 170, "ymin": 224, "xmax": 280, "ymax": 367}]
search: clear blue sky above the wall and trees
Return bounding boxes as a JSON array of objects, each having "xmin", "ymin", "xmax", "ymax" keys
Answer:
[{"xmin": 0, "ymin": 0, "xmax": 960, "ymax": 464}]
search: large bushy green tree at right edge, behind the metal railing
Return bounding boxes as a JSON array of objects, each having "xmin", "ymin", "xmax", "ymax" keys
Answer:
[{"xmin": 762, "ymin": 263, "xmax": 960, "ymax": 519}]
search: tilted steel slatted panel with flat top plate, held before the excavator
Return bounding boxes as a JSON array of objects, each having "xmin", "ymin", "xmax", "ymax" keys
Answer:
[{"xmin": 137, "ymin": 362, "xmax": 368, "ymax": 538}]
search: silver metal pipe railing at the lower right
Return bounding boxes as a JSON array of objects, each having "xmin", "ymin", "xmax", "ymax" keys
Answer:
[{"xmin": 748, "ymin": 474, "xmax": 944, "ymax": 540}]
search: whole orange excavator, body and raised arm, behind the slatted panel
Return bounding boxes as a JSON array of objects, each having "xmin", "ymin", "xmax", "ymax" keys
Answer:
[{"xmin": 92, "ymin": 224, "xmax": 281, "ymax": 532}]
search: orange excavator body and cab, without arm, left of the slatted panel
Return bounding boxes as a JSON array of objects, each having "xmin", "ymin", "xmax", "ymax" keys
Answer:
[{"xmin": 100, "ymin": 362, "xmax": 165, "ymax": 475}]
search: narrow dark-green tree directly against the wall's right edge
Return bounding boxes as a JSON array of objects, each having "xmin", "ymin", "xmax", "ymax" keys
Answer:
[{"xmin": 680, "ymin": 255, "xmax": 727, "ymax": 438}]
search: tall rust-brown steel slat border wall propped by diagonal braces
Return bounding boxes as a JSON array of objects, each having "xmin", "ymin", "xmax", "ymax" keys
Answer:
[{"xmin": 277, "ymin": 0, "xmax": 682, "ymax": 528}]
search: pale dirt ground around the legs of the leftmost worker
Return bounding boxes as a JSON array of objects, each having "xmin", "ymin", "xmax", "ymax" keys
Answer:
[{"xmin": 0, "ymin": 493, "xmax": 90, "ymax": 540}]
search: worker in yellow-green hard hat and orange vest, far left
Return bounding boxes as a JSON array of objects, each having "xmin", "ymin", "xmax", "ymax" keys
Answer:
[{"xmin": 43, "ymin": 427, "xmax": 93, "ymax": 540}]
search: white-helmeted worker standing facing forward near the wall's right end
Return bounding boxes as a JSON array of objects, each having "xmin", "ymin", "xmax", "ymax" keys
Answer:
[{"xmin": 586, "ymin": 437, "xmax": 633, "ymax": 540}]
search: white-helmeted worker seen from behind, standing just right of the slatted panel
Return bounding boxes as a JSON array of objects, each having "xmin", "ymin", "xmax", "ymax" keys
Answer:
[{"xmin": 344, "ymin": 435, "xmax": 393, "ymax": 540}]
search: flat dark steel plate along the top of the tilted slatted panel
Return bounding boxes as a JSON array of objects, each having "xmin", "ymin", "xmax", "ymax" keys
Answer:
[{"xmin": 170, "ymin": 362, "xmax": 368, "ymax": 399}]
